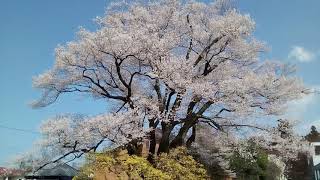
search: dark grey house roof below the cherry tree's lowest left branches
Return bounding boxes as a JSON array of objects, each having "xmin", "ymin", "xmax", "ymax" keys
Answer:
[{"xmin": 30, "ymin": 164, "xmax": 78, "ymax": 177}]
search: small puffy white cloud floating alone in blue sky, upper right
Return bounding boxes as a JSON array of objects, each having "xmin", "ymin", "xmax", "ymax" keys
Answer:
[{"xmin": 288, "ymin": 46, "xmax": 316, "ymax": 62}]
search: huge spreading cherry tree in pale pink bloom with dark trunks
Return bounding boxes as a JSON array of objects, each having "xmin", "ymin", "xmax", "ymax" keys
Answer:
[{"xmin": 26, "ymin": 0, "xmax": 308, "ymax": 170}]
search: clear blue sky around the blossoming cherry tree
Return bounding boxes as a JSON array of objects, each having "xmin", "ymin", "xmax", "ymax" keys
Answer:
[{"xmin": 0, "ymin": 0, "xmax": 320, "ymax": 166}]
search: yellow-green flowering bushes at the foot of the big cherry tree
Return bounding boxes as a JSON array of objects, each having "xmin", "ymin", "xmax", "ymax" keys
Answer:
[{"xmin": 74, "ymin": 147, "xmax": 207, "ymax": 180}]
